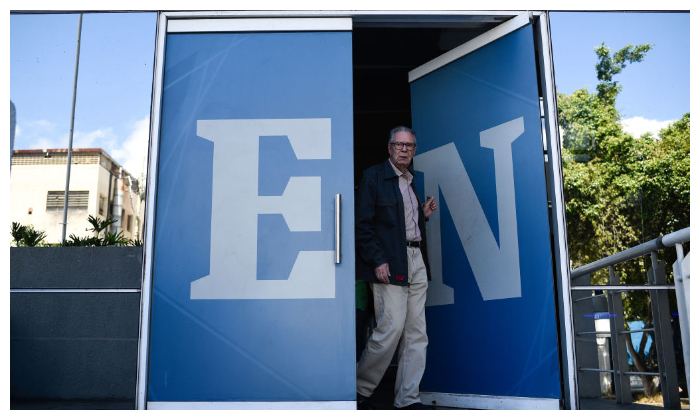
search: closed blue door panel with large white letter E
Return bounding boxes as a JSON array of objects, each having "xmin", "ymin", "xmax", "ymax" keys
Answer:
[{"xmin": 148, "ymin": 32, "xmax": 355, "ymax": 402}]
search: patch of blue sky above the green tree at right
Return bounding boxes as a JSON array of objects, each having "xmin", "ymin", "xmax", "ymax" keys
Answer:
[{"xmin": 550, "ymin": 12, "xmax": 690, "ymax": 135}]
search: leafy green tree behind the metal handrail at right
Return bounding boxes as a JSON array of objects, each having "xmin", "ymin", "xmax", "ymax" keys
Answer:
[{"xmin": 558, "ymin": 43, "xmax": 690, "ymax": 394}]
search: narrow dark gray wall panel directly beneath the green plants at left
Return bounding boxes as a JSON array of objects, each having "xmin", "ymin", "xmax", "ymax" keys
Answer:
[{"xmin": 10, "ymin": 246, "xmax": 143, "ymax": 289}]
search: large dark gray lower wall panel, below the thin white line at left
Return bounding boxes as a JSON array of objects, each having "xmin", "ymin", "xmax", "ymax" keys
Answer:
[{"xmin": 10, "ymin": 293, "xmax": 139, "ymax": 400}]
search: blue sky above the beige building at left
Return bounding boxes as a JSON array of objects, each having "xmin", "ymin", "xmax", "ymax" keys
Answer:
[{"xmin": 10, "ymin": 13, "xmax": 156, "ymax": 176}]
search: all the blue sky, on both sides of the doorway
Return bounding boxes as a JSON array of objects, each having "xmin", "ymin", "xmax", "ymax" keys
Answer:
[{"xmin": 10, "ymin": 12, "xmax": 690, "ymax": 176}]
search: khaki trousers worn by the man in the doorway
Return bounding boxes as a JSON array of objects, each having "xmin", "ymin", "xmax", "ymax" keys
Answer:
[{"xmin": 357, "ymin": 247, "xmax": 428, "ymax": 407}]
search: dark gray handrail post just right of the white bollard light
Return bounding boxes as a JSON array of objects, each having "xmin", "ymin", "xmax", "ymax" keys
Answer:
[{"xmin": 608, "ymin": 266, "xmax": 632, "ymax": 404}]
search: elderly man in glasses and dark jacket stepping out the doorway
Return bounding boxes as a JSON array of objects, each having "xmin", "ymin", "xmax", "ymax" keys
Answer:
[{"xmin": 355, "ymin": 127, "xmax": 436, "ymax": 409}]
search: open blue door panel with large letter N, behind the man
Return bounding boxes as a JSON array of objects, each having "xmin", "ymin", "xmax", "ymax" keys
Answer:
[{"xmin": 411, "ymin": 25, "xmax": 561, "ymax": 399}]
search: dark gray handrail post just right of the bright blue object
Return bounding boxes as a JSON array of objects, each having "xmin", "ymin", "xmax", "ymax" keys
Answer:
[{"xmin": 647, "ymin": 251, "xmax": 681, "ymax": 410}]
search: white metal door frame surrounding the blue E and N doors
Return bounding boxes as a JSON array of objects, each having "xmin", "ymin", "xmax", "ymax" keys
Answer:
[{"xmin": 136, "ymin": 11, "xmax": 579, "ymax": 409}]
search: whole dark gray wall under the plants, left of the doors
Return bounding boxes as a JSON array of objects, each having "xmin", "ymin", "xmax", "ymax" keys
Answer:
[{"xmin": 10, "ymin": 247, "xmax": 142, "ymax": 400}]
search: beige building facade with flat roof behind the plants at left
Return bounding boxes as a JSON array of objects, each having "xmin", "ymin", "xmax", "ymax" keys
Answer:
[{"xmin": 10, "ymin": 149, "xmax": 144, "ymax": 244}]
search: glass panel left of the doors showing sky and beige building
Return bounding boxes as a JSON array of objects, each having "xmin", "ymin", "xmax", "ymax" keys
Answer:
[{"xmin": 10, "ymin": 12, "xmax": 157, "ymax": 244}]
